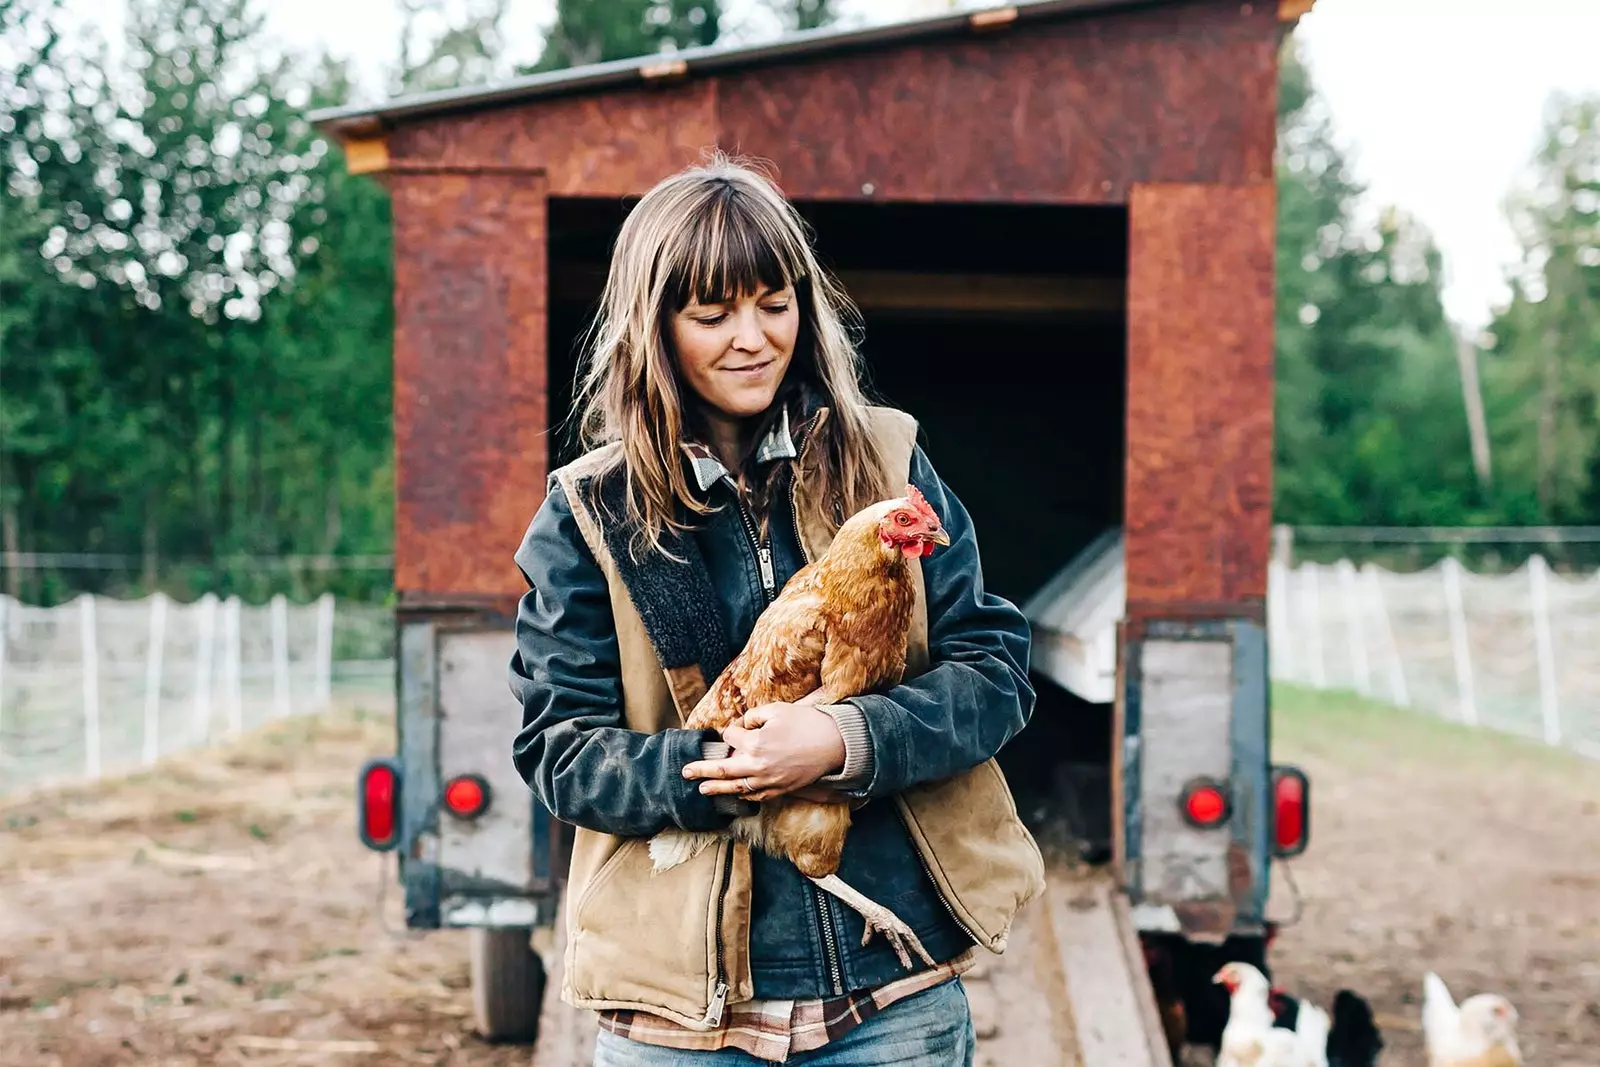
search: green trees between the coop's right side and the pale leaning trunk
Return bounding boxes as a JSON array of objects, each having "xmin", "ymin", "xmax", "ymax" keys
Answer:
[{"xmin": 1275, "ymin": 45, "xmax": 1483, "ymax": 525}]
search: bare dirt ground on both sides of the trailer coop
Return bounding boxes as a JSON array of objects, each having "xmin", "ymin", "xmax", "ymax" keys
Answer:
[{"xmin": 0, "ymin": 694, "xmax": 1600, "ymax": 1067}]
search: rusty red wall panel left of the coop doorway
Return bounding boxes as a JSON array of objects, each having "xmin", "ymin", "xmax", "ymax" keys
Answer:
[{"xmin": 390, "ymin": 173, "xmax": 547, "ymax": 601}]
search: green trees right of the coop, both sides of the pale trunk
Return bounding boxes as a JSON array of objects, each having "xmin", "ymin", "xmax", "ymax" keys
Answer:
[{"xmin": 1275, "ymin": 45, "xmax": 1600, "ymax": 526}]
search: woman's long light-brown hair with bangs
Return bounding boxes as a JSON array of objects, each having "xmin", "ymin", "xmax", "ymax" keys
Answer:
[{"xmin": 574, "ymin": 154, "xmax": 886, "ymax": 563}]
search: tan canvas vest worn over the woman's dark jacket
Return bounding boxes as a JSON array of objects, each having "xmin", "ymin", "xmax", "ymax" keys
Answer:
[{"xmin": 555, "ymin": 408, "xmax": 1045, "ymax": 1029}]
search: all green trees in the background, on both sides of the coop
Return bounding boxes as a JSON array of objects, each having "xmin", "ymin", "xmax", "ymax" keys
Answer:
[{"xmin": 12, "ymin": 0, "xmax": 1600, "ymax": 600}]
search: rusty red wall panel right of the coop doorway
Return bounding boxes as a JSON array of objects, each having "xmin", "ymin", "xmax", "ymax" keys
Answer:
[{"xmin": 1125, "ymin": 184, "xmax": 1277, "ymax": 617}]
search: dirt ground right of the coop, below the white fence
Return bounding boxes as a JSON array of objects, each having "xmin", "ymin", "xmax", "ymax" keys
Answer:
[{"xmin": 1272, "ymin": 689, "xmax": 1600, "ymax": 1067}]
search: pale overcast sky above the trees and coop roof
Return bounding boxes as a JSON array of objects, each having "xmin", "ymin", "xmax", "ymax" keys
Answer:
[{"xmin": 59, "ymin": 0, "xmax": 1600, "ymax": 325}]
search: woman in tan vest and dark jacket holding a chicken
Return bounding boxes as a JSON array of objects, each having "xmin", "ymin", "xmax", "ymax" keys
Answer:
[{"xmin": 510, "ymin": 157, "xmax": 1043, "ymax": 1067}]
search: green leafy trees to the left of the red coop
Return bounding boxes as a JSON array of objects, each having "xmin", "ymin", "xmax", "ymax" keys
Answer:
[{"xmin": 0, "ymin": 0, "xmax": 390, "ymax": 598}]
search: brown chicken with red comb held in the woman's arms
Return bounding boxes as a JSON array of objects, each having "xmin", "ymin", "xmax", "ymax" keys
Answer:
[{"xmin": 650, "ymin": 485, "xmax": 950, "ymax": 968}]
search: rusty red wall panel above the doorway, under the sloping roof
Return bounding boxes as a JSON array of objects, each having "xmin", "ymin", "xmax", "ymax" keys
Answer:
[{"xmin": 389, "ymin": 2, "xmax": 1278, "ymax": 203}]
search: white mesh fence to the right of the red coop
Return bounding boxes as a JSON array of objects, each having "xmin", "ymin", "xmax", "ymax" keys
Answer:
[{"xmin": 1267, "ymin": 555, "xmax": 1600, "ymax": 758}]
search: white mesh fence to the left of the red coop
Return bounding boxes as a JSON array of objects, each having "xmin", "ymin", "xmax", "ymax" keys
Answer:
[{"xmin": 0, "ymin": 593, "xmax": 394, "ymax": 793}]
